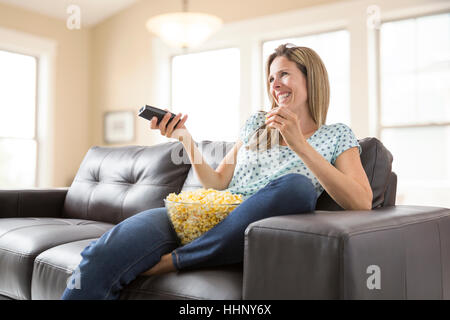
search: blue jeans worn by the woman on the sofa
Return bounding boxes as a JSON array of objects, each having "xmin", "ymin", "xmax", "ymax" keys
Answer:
[{"xmin": 62, "ymin": 173, "xmax": 317, "ymax": 299}]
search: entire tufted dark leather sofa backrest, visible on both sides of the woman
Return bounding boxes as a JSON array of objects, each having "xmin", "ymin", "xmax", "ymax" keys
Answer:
[{"xmin": 63, "ymin": 138, "xmax": 397, "ymax": 223}]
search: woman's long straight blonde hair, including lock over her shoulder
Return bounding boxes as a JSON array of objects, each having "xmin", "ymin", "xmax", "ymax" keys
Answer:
[{"xmin": 246, "ymin": 44, "xmax": 330, "ymax": 150}]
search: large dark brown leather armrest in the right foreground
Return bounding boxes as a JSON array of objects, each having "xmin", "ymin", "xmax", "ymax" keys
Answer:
[{"xmin": 243, "ymin": 206, "xmax": 450, "ymax": 299}]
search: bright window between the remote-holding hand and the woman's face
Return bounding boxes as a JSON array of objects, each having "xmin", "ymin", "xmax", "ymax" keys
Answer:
[{"xmin": 172, "ymin": 48, "xmax": 240, "ymax": 141}]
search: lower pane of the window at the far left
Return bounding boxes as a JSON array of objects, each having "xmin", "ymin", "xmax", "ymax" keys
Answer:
[{"xmin": 0, "ymin": 139, "xmax": 36, "ymax": 188}]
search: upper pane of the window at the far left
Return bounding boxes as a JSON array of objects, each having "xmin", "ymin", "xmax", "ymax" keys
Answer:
[{"xmin": 0, "ymin": 51, "xmax": 36, "ymax": 138}]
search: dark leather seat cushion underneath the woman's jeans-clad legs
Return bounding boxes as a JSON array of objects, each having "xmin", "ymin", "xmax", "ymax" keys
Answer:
[{"xmin": 31, "ymin": 239, "xmax": 242, "ymax": 300}]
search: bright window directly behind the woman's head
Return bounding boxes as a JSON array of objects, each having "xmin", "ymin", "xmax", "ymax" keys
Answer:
[{"xmin": 263, "ymin": 30, "xmax": 350, "ymax": 125}]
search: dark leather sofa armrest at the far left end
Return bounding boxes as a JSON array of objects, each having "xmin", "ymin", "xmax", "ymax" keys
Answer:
[{"xmin": 0, "ymin": 188, "xmax": 68, "ymax": 218}]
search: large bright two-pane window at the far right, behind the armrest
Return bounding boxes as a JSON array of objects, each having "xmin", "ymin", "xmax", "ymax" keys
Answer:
[{"xmin": 380, "ymin": 14, "xmax": 450, "ymax": 207}]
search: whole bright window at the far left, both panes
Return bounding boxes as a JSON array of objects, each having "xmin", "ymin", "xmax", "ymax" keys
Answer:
[{"xmin": 0, "ymin": 51, "xmax": 37, "ymax": 188}]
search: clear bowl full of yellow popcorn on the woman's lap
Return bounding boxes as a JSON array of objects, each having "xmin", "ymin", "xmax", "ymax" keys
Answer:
[{"xmin": 164, "ymin": 188, "xmax": 243, "ymax": 245}]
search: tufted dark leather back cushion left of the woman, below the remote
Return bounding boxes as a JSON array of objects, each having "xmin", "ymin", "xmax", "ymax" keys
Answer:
[{"xmin": 63, "ymin": 141, "xmax": 191, "ymax": 224}]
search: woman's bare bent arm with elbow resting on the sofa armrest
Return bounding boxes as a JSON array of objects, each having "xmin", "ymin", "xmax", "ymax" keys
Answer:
[{"xmin": 294, "ymin": 143, "xmax": 373, "ymax": 210}]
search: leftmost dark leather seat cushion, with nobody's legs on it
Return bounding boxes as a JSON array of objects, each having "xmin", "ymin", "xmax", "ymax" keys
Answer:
[{"xmin": 0, "ymin": 218, "xmax": 112, "ymax": 299}]
